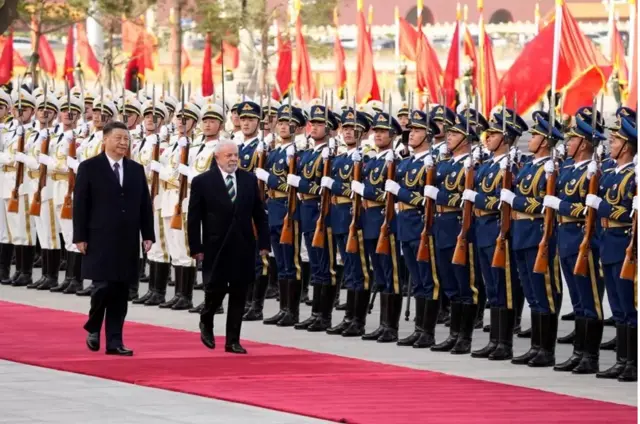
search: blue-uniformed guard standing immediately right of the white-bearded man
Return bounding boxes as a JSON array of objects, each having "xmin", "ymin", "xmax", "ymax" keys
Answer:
[{"xmin": 255, "ymin": 105, "xmax": 306, "ymax": 327}]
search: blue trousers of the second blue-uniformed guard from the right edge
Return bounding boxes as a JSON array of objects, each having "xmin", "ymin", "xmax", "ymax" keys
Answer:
[{"xmin": 560, "ymin": 251, "xmax": 604, "ymax": 319}]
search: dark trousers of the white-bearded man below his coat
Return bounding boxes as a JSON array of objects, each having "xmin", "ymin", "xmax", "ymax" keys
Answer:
[{"xmin": 200, "ymin": 281, "xmax": 248, "ymax": 345}]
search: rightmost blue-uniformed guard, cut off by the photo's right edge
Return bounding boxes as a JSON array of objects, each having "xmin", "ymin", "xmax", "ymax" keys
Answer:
[{"xmin": 586, "ymin": 112, "xmax": 638, "ymax": 381}]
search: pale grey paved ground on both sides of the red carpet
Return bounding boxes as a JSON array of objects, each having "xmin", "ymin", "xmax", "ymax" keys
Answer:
[{"xmin": 0, "ymin": 271, "xmax": 637, "ymax": 423}]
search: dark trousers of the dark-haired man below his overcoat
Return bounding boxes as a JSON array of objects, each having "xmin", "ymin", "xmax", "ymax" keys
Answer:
[{"xmin": 84, "ymin": 281, "xmax": 130, "ymax": 349}]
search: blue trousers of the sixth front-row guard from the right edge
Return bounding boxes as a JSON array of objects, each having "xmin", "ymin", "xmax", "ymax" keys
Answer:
[{"xmin": 402, "ymin": 237, "xmax": 440, "ymax": 300}]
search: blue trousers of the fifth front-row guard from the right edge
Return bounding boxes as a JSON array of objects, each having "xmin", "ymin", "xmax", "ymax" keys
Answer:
[{"xmin": 436, "ymin": 244, "xmax": 480, "ymax": 304}]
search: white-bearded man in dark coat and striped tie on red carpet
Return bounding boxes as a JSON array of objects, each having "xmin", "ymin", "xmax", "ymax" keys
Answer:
[{"xmin": 187, "ymin": 140, "xmax": 269, "ymax": 353}]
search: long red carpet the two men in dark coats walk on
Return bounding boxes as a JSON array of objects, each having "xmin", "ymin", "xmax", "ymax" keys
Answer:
[{"xmin": 0, "ymin": 302, "xmax": 637, "ymax": 424}]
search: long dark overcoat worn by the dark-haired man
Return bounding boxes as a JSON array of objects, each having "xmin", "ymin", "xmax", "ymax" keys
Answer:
[{"xmin": 73, "ymin": 153, "xmax": 155, "ymax": 282}]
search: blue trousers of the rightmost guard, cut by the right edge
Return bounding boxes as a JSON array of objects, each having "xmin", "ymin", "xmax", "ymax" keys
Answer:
[{"xmin": 603, "ymin": 262, "xmax": 638, "ymax": 327}]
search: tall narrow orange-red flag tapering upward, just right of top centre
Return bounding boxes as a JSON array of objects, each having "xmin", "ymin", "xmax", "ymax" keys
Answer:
[{"xmin": 356, "ymin": 8, "xmax": 380, "ymax": 103}]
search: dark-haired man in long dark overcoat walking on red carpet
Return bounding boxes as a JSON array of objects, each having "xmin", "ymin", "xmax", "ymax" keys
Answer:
[{"xmin": 73, "ymin": 122, "xmax": 155, "ymax": 356}]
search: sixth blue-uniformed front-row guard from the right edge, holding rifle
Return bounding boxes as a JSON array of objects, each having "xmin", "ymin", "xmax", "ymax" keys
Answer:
[{"xmin": 385, "ymin": 110, "xmax": 440, "ymax": 348}]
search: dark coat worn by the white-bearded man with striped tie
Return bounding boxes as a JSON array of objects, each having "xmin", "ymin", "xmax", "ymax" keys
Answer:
[{"xmin": 187, "ymin": 166, "xmax": 270, "ymax": 288}]
